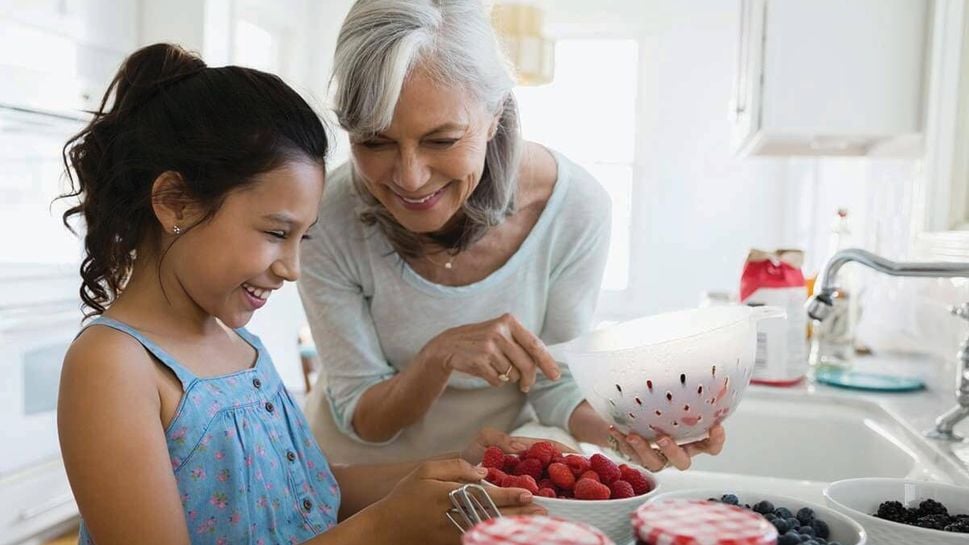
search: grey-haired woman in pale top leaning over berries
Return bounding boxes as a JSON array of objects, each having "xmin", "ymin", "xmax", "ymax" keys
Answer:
[{"xmin": 300, "ymin": 0, "xmax": 723, "ymax": 470}]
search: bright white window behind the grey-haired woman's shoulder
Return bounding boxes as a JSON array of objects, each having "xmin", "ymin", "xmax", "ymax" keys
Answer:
[{"xmin": 515, "ymin": 38, "xmax": 639, "ymax": 291}]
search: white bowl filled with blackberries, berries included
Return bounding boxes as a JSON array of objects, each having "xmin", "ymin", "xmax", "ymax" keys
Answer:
[{"xmin": 824, "ymin": 478, "xmax": 969, "ymax": 545}]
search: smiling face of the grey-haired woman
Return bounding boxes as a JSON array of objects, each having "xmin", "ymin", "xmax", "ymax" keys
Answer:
[{"xmin": 351, "ymin": 69, "xmax": 497, "ymax": 233}]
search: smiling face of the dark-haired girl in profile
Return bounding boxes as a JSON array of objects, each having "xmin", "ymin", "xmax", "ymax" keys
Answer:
[{"xmin": 165, "ymin": 161, "xmax": 324, "ymax": 328}]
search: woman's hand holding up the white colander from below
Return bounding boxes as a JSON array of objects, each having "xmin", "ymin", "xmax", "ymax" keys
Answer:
[{"xmin": 609, "ymin": 424, "xmax": 727, "ymax": 472}]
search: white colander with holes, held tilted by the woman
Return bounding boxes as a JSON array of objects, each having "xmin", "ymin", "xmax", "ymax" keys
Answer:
[{"xmin": 550, "ymin": 305, "xmax": 784, "ymax": 444}]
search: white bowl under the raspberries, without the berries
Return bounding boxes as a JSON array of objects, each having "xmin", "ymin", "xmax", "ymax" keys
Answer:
[{"xmin": 482, "ymin": 468, "xmax": 656, "ymax": 545}]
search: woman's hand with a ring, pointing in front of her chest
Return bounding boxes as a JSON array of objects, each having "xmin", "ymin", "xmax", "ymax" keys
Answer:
[{"xmin": 421, "ymin": 314, "xmax": 561, "ymax": 392}]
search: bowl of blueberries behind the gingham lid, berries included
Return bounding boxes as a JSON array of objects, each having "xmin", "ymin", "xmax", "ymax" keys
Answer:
[{"xmin": 649, "ymin": 488, "xmax": 868, "ymax": 545}]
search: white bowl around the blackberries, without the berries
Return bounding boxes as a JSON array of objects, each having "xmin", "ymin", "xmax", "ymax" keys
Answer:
[{"xmin": 824, "ymin": 478, "xmax": 969, "ymax": 545}]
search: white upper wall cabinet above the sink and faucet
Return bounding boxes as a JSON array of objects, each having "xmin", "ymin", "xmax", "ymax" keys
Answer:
[{"xmin": 731, "ymin": 0, "xmax": 931, "ymax": 155}]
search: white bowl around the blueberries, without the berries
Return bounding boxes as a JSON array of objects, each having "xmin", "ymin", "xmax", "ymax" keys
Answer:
[{"xmin": 649, "ymin": 488, "xmax": 864, "ymax": 545}]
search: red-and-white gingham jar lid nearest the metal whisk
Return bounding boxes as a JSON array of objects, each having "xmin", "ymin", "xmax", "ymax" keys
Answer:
[{"xmin": 461, "ymin": 515, "xmax": 614, "ymax": 545}]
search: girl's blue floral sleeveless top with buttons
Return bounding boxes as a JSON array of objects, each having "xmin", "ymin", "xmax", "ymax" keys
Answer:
[{"xmin": 80, "ymin": 316, "xmax": 340, "ymax": 545}]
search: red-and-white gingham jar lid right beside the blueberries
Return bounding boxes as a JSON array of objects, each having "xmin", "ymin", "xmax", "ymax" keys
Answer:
[{"xmin": 632, "ymin": 499, "xmax": 777, "ymax": 545}]
